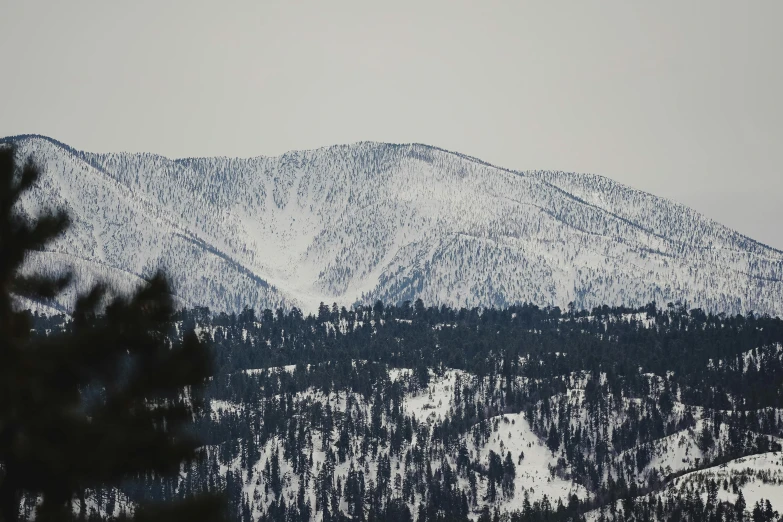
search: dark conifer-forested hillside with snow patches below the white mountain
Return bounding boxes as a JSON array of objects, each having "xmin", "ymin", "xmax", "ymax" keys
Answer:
[{"xmin": 26, "ymin": 300, "xmax": 783, "ymax": 522}]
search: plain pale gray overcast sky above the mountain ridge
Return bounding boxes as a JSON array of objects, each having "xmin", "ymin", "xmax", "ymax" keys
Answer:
[{"xmin": 0, "ymin": 0, "xmax": 783, "ymax": 248}]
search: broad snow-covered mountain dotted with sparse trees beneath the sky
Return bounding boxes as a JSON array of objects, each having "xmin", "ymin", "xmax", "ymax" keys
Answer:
[{"xmin": 7, "ymin": 136, "xmax": 783, "ymax": 315}]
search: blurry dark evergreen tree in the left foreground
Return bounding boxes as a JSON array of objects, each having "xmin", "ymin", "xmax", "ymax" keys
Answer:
[{"xmin": 0, "ymin": 145, "xmax": 223, "ymax": 522}]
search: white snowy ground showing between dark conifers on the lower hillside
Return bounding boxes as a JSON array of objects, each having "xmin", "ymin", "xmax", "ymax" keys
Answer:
[{"xmin": 199, "ymin": 360, "xmax": 783, "ymax": 520}]
